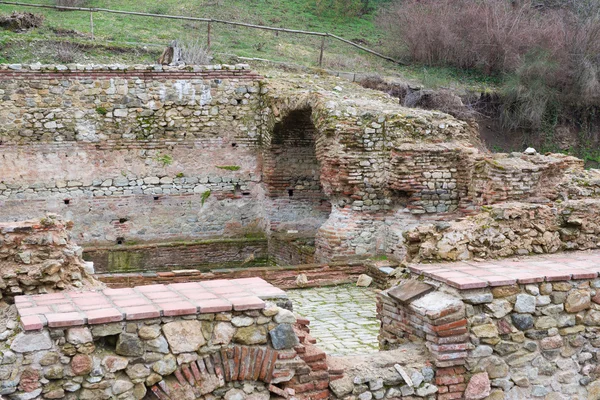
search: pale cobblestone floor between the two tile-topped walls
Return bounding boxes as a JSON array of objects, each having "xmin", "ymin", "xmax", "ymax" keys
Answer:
[{"xmin": 287, "ymin": 285, "xmax": 379, "ymax": 356}]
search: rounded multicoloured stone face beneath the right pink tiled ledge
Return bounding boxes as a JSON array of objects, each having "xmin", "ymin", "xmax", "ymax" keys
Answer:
[{"xmin": 454, "ymin": 279, "xmax": 600, "ymax": 399}]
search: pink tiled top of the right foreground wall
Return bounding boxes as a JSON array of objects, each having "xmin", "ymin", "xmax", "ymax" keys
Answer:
[{"xmin": 409, "ymin": 251, "xmax": 600, "ymax": 289}]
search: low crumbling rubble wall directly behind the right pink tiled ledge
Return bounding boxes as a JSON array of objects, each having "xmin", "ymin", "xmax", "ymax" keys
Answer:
[{"xmin": 404, "ymin": 199, "xmax": 600, "ymax": 262}]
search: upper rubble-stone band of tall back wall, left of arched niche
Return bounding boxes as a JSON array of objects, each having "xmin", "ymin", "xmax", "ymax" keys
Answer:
[{"xmin": 0, "ymin": 64, "xmax": 260, "ymax": 144}]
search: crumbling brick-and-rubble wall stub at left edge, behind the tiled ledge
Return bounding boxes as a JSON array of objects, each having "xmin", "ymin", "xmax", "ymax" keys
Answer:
[{"xmin": 0, "ymin": 215, "xmax": 101, "ymax": 302}]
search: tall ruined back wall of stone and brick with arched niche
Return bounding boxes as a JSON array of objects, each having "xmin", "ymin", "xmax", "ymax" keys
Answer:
[{"xmin": 0, "ymin": 64, "xmax": 597, "ymax": 263}]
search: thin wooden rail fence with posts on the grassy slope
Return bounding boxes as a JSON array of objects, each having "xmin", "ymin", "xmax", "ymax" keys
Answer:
[{"xmin": 0, "ymin": 0, "xmax": 406, "ymax": 66}]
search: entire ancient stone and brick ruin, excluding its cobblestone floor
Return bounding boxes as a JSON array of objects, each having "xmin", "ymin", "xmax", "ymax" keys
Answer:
[{"xmin": 0, "ymin": 64, "xmax": 600, "ymax": 400}]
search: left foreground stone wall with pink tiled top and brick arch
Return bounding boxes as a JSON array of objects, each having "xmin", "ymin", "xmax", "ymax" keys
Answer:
[{"xmin": 0, "ymin": 279, "xmax": 329, "ymax": 400}]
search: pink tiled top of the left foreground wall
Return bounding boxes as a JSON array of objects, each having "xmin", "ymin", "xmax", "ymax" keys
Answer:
[{"xmin": 15, "ymin": 278, "xmax": 285, "ymax": 331}]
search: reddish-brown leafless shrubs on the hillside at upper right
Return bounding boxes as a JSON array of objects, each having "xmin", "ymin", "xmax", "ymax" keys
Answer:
[{"xmin": 379, "ymin": 0, "xmax": 600, "ymax": 129}]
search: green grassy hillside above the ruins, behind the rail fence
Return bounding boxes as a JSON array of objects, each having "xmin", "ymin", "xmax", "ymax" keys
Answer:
[{"xmin": 0, "ymin": 0, "xmax": 494, "ymax": 90}]
